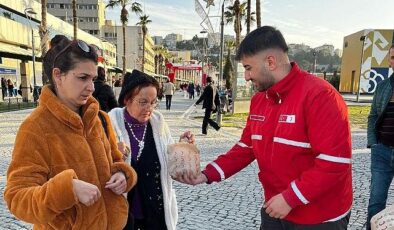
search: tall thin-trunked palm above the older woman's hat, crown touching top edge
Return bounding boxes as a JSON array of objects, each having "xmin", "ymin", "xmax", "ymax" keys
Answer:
[{"xmin": 106, "ymin": 0, "xmax": 142, "ymax": 74}]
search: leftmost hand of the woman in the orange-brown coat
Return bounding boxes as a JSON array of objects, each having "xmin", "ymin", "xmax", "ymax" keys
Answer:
[{"xmin": 72, "ymin": 179, "xmax": 101, "ymax": 206}]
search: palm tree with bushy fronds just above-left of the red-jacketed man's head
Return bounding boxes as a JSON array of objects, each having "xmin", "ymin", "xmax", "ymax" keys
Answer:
[{"xmin": 224, "ymin": 0, "xmax": 255, "ymax": 47}]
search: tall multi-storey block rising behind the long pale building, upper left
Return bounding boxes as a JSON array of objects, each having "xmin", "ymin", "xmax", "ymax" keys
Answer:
[{"xmin": 47, "ymin": 0, "xmax": 105, "ymax": 37}]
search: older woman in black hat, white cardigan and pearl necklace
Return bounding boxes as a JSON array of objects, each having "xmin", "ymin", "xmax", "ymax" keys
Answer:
[{"xmin": 109, "ymin": 70, "xmax": 194, "ymax": 230}]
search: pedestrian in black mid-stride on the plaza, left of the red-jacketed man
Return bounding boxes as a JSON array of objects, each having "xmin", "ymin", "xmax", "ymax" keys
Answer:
[{"xmin": 195, "ymin": 77, "xmax": 220, "ymax": 135}]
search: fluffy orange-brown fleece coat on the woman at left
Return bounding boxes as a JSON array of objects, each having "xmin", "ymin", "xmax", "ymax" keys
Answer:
[{"xmin": 4, "ymin": 87, "xmax": 137, "ymax": 230}]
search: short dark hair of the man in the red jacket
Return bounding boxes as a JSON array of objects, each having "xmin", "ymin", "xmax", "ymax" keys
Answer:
[{"xmin": 235, "ymin": 26, "xmax": 289, "ymax": 60}]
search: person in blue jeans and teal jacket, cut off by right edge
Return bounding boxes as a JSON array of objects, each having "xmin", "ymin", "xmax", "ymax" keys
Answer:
[{"xmin": 367, "ymin": 44, "xmax": 394, "ymax": 230}]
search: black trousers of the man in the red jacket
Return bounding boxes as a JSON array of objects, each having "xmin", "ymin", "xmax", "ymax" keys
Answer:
[{"xmin": 260, "ymin": 208, "xmax": 350, "ymax": 230}]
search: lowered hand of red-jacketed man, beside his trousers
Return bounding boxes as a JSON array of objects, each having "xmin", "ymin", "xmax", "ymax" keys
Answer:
[{"xmin": 263, "ymin": 194, "xmax": 291, "ymax": 219}]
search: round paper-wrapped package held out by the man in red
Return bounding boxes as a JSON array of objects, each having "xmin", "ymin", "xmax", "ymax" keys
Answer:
[{"xmin": 167, "ymin": 142, "xmax": 201, "ymax": 177}]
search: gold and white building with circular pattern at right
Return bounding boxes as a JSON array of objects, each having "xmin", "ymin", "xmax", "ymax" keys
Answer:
[{"xmin": 339, "ymin": 29, "xmax": 394, "ymax": 94}]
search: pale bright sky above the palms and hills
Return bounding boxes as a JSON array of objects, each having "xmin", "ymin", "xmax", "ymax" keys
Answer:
[{"xmin": 105, "ymin": 0, "xmax": 394, "ymax": 49}]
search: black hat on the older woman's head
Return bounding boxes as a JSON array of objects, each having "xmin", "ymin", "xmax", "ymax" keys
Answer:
[{"xmin": 118, "ymin": 70, "xmax": 160, "ymax": 106}]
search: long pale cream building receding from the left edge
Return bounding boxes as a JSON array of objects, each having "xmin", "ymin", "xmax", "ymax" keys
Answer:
[{"xmin": 0, "ymin": 0, "xmax": 116, "ymax": 100}]
